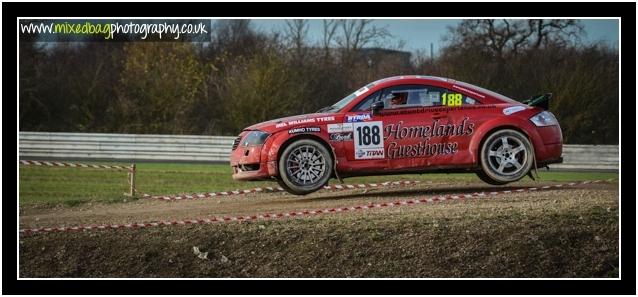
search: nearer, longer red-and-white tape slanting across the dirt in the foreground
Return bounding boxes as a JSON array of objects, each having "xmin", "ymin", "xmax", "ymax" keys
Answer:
[{"xmin": 20, "ymin": 180, "xmax": 611, "ymax": 234}]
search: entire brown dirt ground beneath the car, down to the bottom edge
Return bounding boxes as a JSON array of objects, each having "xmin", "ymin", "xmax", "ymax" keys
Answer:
[{"xmin": 19, "ymin": 183, "xmax": 618, "ymax": 277}]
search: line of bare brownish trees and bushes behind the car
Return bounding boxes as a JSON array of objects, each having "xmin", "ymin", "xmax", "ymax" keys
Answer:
[{"xmin": 19, "ymin": 20, "xmax": 619, "ymax": 144}]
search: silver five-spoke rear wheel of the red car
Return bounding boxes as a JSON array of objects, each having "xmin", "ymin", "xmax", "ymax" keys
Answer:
[{"xmin": 477, "ymin": 129, "xmax": 534, "ymax": 185}]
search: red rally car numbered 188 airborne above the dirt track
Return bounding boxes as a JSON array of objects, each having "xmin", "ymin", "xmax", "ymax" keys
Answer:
[{"xmin": 230, "ymin": 75, "xmax": 563, "ymax": 195}]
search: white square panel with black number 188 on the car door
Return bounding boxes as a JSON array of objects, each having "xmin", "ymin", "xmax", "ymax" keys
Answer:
[{"xmin": 353, "ymin": 121, "xmax": 385, "ymax": 159}]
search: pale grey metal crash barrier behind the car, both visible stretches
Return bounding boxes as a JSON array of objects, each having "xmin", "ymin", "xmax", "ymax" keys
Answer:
[{"xmin": 19, "ymin": 132, "xmax": 619, "ymax": 170}]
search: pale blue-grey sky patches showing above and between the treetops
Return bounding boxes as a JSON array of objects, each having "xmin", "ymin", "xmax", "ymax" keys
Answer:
[{"xmin": 252, "ymin": 19, "xmax": 618, "ymax": 52}]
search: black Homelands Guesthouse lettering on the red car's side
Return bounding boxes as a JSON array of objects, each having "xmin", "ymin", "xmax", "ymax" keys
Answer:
[{"xmin": 384, "ymin": 117, "xmax": 474, "ymax": 159}]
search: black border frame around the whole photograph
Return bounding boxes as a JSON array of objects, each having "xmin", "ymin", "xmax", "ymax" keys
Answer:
[{"xmin": 2, "ymin": 2, "xmax": 636, "ymax": 295}]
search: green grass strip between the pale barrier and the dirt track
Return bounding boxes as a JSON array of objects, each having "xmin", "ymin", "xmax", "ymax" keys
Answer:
[{"xmin": 18, "ymin": 162, "xmax": 618, "ymax": 206}]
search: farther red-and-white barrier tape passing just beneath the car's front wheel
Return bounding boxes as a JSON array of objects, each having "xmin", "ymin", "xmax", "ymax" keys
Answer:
[{"xmin": 141, "ymin": 181, "xmax": 420, "ymax": 201}]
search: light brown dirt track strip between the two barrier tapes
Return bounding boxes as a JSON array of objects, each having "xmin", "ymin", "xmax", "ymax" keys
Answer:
[{"xmin": 20, "ymin": 183, "xmax": 606, "ymax": 228}]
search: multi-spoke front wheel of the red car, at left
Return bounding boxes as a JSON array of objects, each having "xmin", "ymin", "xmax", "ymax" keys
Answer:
[{"xmin": 279, "ymin": 139, "xmax": 333, "ymax": 195}]
